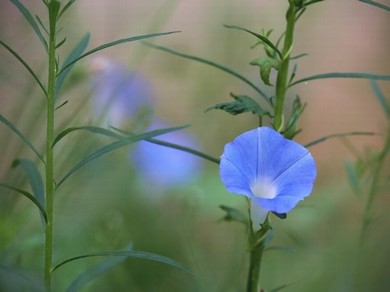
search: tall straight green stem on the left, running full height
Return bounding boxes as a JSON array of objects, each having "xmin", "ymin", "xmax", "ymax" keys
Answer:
[{"xmin": 44, "ymin": 1, "xmax": 59, "ymax": 291}]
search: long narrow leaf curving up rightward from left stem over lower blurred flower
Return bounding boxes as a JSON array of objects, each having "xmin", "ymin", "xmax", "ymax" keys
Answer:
[{"xmin": 56, "ymin": 126, "xmax": 188, "ymax": 188}]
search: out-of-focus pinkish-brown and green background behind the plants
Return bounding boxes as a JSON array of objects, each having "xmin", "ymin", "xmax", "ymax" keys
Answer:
[{"xmin": 0, "ymin": 0, "xmax": 390, "ymax": 291}]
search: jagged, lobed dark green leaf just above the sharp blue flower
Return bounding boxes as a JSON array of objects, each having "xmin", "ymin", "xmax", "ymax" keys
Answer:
[{"xmin": 206, "ymin": 93, "xmax": 270, "ymax": 116}]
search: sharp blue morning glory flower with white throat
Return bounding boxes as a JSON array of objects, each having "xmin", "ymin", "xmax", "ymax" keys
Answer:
[{"xmin": 220, "ymin": 127, "xmax": 317, "ymax": 223}]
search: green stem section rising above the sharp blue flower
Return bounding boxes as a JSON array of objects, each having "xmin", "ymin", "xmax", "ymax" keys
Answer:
[{"xmin": 274, "ymin": 0, "xmax": 297, "ymax": 131}]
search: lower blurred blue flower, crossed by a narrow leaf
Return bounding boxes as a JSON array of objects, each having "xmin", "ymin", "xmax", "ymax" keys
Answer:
[{"xmin": 131, "ymin": 119, "xmax": 202, "ymax": 189}]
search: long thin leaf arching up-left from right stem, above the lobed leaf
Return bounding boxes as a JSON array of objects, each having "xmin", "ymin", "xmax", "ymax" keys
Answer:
[{"xmin": 144, "ymin": 43, "xmax": 270, "ymax": 104}]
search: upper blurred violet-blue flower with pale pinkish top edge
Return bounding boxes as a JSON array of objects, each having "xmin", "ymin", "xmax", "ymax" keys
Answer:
[{"xmin": 92, "ymin": 56, "xmax": 154, "ymax": 127}]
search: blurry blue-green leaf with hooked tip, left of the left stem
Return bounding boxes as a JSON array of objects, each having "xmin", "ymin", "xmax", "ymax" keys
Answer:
[{"xmin": 13, "ymin": 159, "xmax": 45, "ymax": 206}]
